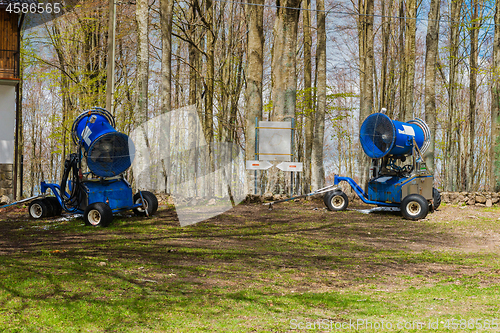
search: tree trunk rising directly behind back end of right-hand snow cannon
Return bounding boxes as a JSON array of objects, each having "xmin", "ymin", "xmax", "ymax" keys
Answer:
[{"xmin": 424, "ymin": 0, "xmax": 440, "ymax": 174}]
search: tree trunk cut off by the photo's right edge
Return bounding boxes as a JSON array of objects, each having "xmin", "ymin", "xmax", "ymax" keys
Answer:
[{"xmin": 490, "ymin": 0, "xmax": 500, "ymax": 192}]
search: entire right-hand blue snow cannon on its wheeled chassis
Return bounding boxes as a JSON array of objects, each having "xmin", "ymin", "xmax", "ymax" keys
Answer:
[{"xmin": 324, "ymin": 113, "xmax": 441, "ymax": 220}]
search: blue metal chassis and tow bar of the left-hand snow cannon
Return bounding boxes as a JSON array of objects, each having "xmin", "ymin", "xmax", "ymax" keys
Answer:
[{"xmin": 40, "ymin": 179, "xmax": 142, "ymax": 214}]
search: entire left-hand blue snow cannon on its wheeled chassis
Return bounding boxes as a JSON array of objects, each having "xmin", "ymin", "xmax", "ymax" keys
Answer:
[{"xmin": 29, "ymin": 108, "xmax": 158, "ymax": 226}]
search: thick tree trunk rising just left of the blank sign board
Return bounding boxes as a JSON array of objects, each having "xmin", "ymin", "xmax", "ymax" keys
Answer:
[{"xmin": 245, "ymin": 0, "xmax": 264, "ymax": 193}]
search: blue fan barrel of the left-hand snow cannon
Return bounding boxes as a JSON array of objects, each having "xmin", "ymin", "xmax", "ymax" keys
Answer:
[{"xmin": 71, "ymin": 108, "xmax": 135, "ymax": 177}]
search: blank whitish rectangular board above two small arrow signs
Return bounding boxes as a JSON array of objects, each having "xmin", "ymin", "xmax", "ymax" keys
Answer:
[{"xmin": 258, "ymin": 121, "xmax": 292, "ymax": 161}]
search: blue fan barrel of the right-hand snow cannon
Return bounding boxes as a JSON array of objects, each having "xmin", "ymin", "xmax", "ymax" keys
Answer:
[{"xmin": 359, "ymin": 113, "xmax": 430, "ymax": 159}]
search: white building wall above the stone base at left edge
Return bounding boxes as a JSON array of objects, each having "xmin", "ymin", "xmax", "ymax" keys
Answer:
[{"xmin": 0, "ymin": 85, "xmax": 16, "ymax": 164}]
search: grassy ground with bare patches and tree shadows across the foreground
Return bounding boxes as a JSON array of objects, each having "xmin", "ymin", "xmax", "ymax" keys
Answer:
[{"xmin": 0, "ymin": 203, "xmax": 500, "ymax": 332}]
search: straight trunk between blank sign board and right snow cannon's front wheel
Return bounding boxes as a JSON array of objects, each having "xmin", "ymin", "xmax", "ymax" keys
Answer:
[{"xmin": 311, "ymin": 0, "xmax": 326, "ymax": 190}]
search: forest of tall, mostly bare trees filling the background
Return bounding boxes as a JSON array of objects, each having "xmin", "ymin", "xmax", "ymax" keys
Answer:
[{"xmin": 15, "ymin": 0, "xmax": 500, "ymax": 195}]
